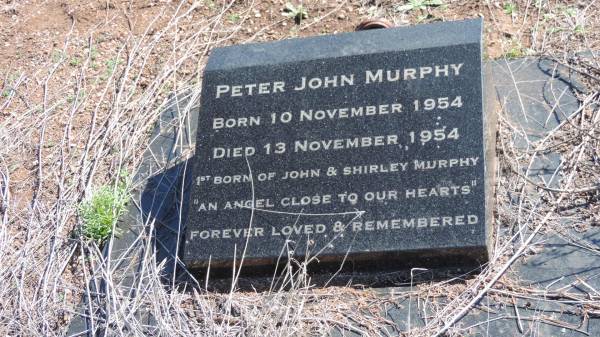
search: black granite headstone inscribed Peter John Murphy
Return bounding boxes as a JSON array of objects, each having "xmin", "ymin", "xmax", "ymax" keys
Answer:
[{"xmin": 182, "ymin": 20, "xmax": 495, "ymax": 269}]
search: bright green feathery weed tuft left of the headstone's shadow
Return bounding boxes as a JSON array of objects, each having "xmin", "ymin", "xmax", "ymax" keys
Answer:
[{"xmin": 79, "ymin": 174, "xmax": 130, "ymax": 243}]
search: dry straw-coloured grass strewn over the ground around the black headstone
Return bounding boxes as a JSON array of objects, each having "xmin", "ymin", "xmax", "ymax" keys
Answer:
[{"xmin": 0, "ymin": 1, "xmax": 600, "ymax": 336}]
